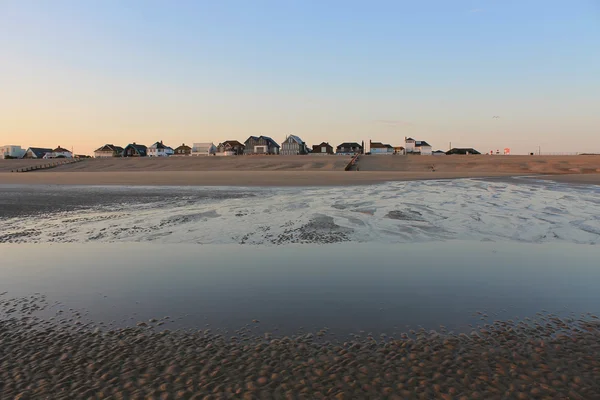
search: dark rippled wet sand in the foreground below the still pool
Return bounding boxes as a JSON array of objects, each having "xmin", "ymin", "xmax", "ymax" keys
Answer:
[{"xmin": 0, "ymin": 294, "xmax": 600, "ymax": 400}]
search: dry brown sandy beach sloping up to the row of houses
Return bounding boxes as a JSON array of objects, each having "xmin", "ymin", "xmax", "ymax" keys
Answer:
[{"xmin": 0, "ymin": 156, "xmax": 600, "ymax": 186}]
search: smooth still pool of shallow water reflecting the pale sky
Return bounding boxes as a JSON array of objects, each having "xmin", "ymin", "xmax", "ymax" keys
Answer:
[{"xmin": 0, "ymin": 241, "xmax": 600, "ymax": 335}]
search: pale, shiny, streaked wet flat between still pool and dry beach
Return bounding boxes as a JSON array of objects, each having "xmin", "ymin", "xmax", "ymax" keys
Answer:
[{"xmin": 0, "ymin": 179, "xmax": 600, "ymax": 245}]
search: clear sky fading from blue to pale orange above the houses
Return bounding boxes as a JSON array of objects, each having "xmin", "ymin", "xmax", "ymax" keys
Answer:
[{"xmin": 0, "ymin": 0, "xmax": 600, "ymax": 154}]
